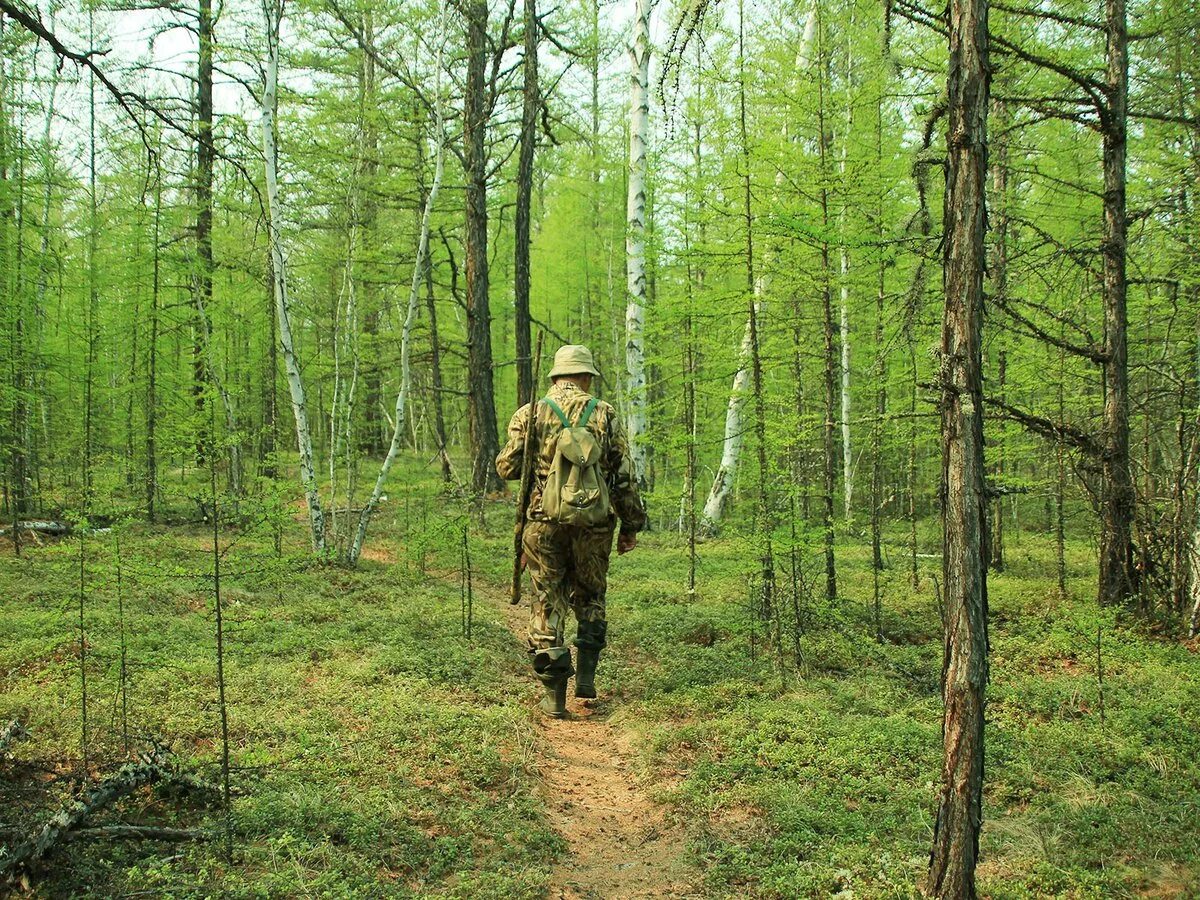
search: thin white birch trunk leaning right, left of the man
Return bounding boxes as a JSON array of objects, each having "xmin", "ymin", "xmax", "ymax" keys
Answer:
[{"xmin": 346, "ymin": 4, "xmax": 446, "ymax": 565}]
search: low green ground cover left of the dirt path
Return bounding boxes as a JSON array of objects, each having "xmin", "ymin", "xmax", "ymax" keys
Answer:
[{"xmin": 0, "ymin": 468, "xmax": 562, "ymax": 898}]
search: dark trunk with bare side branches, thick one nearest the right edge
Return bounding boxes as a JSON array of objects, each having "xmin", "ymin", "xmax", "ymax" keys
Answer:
[{"xmin": 1099, "ymin": 0, "xmax": 1138, "ymax": 606}]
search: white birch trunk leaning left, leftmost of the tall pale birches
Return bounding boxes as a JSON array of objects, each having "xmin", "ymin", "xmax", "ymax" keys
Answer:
[{"xmin": 262, "ymin": 0, "xmax": 325, "ymax": 553}]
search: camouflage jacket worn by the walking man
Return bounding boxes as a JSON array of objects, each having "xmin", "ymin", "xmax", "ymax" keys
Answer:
[{"xmin": 496, "ymin": 382, "xmax": 646, "ymax": 534}]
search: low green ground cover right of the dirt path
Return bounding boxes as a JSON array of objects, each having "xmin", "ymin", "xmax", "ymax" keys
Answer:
[{"xmin": 613, "ymin": 534, "xmax": 1200, "ymax": 898}]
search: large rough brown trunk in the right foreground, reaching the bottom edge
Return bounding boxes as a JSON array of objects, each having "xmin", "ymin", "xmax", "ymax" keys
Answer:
[{"xmin": 925, "ymin": 0, "xmax": 990, "ymax": 900}]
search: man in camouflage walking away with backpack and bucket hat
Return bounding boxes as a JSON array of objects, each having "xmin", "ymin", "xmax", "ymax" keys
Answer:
[{"xmin": 496, "ymin": 344, "xmax": 646, "ymax": 719}]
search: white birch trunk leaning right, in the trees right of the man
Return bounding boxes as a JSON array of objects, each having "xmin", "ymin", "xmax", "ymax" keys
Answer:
[{"xmin": 700, "ymin": 7, "xmax": 817, "ymax": 534}]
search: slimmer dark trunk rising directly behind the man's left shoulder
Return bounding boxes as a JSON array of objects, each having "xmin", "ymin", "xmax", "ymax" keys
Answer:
[{"xmin": 512, "ymin": 0, "xmax": 541, "ymax": 407}]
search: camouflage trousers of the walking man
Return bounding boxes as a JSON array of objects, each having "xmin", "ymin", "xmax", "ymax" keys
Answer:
[{"xmin": 522, "ymin": 522, "xmax": 613, "ymax": 650}]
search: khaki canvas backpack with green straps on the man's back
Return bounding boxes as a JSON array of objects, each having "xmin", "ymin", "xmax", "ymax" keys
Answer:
[{"xmin": 541, "ymin": 397, "xmax": 612, "ymax": 527}]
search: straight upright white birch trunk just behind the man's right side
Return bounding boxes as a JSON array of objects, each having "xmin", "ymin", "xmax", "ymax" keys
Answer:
[{"xmin": 625, "ymin": 0, "xmax": 650, "ymax": 482}]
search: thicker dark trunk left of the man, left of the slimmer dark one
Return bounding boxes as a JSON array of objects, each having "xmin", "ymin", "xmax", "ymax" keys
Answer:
[{"xmin": 463, "ymin": 0, "xmax": 504, "ymax": 493}]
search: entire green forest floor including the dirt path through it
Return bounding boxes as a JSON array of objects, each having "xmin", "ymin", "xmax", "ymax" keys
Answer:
[{"xmin": 0, "ymin": 461, "xmax": 1200, "ymax": 900}]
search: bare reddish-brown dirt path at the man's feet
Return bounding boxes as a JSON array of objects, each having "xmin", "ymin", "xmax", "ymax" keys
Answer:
[{"xmin": 498, "ymin": 599, "xmax": 700, "ymax": 900}]
